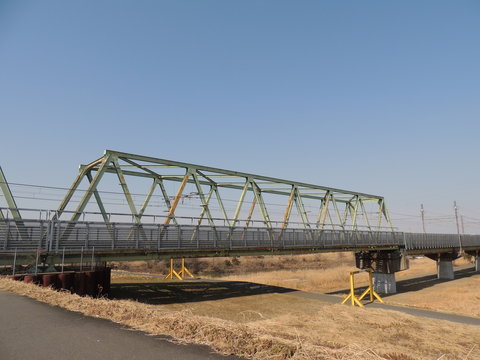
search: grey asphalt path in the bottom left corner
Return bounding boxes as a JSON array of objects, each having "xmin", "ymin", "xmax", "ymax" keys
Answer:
[{"xmin": 0, "ymin": 291, "xmax": 238, "ymax": 360}]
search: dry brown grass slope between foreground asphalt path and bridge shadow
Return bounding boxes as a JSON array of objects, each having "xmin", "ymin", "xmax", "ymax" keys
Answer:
[{"xmin": 0, "ymin": 279, "xmax": 480, "ymax": 360}]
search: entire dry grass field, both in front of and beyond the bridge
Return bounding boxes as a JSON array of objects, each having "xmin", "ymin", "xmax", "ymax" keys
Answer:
[{"xmin": 0, "ymin": 253, "xmax": 480, "ymax": 360}]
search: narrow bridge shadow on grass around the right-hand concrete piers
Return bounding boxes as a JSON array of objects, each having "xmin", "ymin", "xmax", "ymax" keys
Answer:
[{"xmin": 328, "ymin": 267, "xmax": 478, "ymax": 297}]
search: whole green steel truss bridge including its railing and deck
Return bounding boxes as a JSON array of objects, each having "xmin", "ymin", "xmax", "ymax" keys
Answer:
[{"xmin": 0, "ymin": 150, "xmax": 480, "ymax": 265}]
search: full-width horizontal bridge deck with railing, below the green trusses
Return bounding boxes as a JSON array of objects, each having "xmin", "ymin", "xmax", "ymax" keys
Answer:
[{"xmin": 0, "ymin": 220, "xmax": 480, "ymax": 265}]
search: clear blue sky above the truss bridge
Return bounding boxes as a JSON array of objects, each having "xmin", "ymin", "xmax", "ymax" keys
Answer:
[{"xmin": 0, "ymin": 0, "xmax": 480, "ymax": 233}]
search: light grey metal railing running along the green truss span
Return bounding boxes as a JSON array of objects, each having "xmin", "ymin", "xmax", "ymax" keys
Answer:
[{"xmin": 0, "ymin": 220, "xmax": 404, "ymax": 252}]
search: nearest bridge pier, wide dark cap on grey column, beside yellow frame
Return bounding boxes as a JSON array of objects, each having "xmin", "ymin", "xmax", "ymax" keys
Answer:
[{"xmin": 355, "ymin": 250, "xmax": 408, "ymax": 294}]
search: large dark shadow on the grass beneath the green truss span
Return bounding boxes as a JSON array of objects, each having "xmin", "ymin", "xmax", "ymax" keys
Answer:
[{"xmin": 110, "ymin": 281, "xmax": 296, "ymax": 305}]
